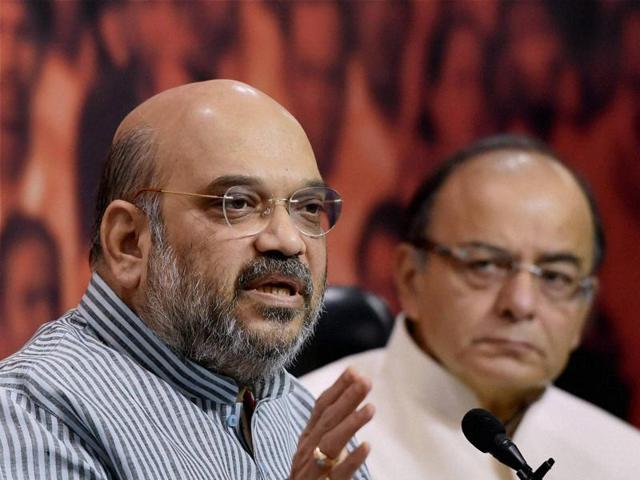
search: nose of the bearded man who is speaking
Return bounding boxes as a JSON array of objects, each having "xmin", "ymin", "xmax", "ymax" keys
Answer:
[{"xmin": 255, "ymin": 202, "xmax": 306, "ymax": 257}]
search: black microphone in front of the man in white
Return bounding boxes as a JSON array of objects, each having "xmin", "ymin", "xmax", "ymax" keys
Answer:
[{"xmin": 462, "ymin": 408, "xmax": 554, "ymax": 480}]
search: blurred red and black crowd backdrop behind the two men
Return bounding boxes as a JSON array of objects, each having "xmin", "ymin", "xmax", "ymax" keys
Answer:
[{"xmin": 0, "ymin": 0, "xmax": 640, "ymax": 425}]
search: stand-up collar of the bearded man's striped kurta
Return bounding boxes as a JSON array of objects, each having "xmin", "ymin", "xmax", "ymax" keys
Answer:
[{"xmin": 78, "ymin": 273, "xmax": 293, "ymax": 403}]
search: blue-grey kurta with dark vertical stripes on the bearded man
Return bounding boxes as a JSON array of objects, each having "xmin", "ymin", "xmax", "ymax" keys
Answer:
[{"xmin": 0, "ymin": 274, "xmax": 368, "ymax": 480}]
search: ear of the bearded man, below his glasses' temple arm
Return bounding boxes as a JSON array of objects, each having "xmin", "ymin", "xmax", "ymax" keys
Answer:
[{"xmin": 100, "ymin": 200, "xmax": 151, "ymax": 289}]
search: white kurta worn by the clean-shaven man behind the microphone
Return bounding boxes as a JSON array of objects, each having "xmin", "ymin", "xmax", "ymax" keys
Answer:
[{"xmin": 302, "ymin": 317, "xmax": 640, "ymax": 480}]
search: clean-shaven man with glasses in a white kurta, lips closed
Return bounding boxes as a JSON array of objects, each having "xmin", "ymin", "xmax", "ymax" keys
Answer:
[{"xmin": 303, "ymin": 135, "xmax": 640, "ymax": 480}]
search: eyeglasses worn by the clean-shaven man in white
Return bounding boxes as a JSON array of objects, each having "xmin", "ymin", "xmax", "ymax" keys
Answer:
[{"xmin": 411, "ymin": 238, "xmax": 598, "ymax": 302}]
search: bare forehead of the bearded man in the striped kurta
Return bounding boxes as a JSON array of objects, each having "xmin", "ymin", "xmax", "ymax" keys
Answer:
[{"xmin": 150, "ymin": 91, "xmax": 320, "ymax": 194}]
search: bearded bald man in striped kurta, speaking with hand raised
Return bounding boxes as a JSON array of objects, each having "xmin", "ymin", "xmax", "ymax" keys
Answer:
[{"xmin": 0, "ymin": 80, "xmax": 373, "ymax": 480}]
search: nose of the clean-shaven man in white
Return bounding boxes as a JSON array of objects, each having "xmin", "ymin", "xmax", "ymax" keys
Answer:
[{"xmin": 496, "ymin": 269, "xmax": 538, "ymax": 322}]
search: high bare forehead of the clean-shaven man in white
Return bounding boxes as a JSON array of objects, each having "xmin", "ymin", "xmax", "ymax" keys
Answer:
[{"xmin": 429, "ymin": 151, "xmax": 594, "ymax": 265}]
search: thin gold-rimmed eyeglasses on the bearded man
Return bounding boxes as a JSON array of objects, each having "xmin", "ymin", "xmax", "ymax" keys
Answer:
[{"xmin": 134, "ymin": 185, "xmax": 342, "ymax": 237}]
